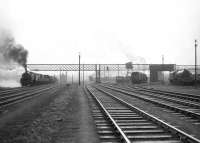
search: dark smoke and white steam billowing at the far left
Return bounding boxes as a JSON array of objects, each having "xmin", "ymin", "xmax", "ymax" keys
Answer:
[{"xmin": 0, "ymin": 29, "xmax": 28, "ymax": 87}]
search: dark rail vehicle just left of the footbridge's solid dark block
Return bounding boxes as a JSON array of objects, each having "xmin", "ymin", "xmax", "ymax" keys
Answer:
[{"xmin": 131, "ymin": 72, "xmax": 148, "ymax": 84}]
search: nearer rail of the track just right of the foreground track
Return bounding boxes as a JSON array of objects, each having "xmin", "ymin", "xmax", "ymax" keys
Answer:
[{"xmin": 101, "ymin": 85, "xmax": 200, "ymax": 120}]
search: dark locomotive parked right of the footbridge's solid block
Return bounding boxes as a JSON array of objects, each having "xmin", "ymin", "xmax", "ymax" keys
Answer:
[{"xmin": 169, "ymin": 69, "xmax": 194, "ymax": 85}]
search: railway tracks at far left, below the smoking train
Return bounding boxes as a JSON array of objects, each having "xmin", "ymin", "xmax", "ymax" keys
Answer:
[{"xmin": 0, "ymin": 85, "xmax": 59, "ymax": 109}]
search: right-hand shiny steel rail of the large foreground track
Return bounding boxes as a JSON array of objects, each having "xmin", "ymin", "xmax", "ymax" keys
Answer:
[{"xmin": 95, "ymin": 87, "xmax": 200, "ymax": 143}]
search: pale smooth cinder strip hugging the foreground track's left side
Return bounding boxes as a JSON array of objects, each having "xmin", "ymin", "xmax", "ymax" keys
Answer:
[{"xmin": 54, "ymin": 87, "xmax": 99, "ymax": 143}]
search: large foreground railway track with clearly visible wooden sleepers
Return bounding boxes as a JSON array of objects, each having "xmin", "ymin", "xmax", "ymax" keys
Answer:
[{"xmin": 87, "ymin": 86, "xmax": 200, "ymax": 143}]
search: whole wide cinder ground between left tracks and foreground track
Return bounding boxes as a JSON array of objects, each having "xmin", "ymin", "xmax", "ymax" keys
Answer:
[{"xmin": 0, "ymin": 85, "xmax": 99, "ymax": 143}]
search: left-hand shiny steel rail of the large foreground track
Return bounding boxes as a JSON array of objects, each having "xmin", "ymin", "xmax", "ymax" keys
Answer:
[{"xmin": 86, "ymin": 87, "xmax": 131, "ymax": 143}]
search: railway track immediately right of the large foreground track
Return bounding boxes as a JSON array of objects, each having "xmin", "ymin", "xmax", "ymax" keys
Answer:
[{"xmin": 100, "ymin": 85, "xmax": 200, "ymax": 124}]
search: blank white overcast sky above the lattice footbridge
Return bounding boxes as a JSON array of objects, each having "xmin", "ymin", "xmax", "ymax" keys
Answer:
[{"xmin": 0, "ymin": 0, "xmax": 200, "ymax": 64}]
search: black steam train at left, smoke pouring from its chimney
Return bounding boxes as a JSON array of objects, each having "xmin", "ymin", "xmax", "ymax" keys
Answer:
[{"xmin": 20, "ymin": 71, "xmax": 57, "ymax": 86}]
